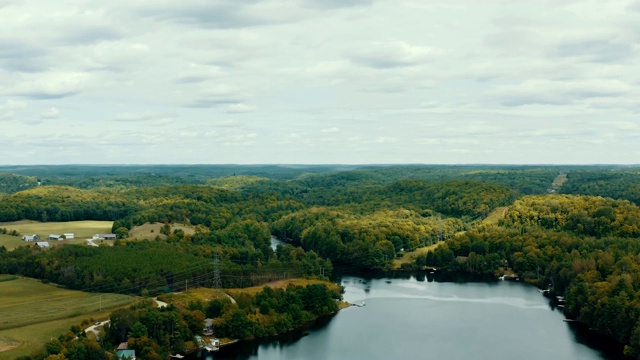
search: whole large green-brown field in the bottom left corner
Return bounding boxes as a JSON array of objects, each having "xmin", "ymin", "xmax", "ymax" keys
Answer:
[{"xmin": 0, "ymin": 275, "xmax": 134, "ymax": 359}]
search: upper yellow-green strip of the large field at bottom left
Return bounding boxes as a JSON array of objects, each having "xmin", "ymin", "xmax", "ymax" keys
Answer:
[{"xmin": 0, "ymin": 279, "xmax": 133, "ymax": 330}]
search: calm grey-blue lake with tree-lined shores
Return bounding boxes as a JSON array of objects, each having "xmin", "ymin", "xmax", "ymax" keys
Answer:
[{"xmin": 192, "ymin": 275, "xmax": 623, "ymax": 360}]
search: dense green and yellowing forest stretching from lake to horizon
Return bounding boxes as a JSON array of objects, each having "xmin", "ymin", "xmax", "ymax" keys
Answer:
[{"xmin": 0, "ymin": 165, "xmax": 640, "ymax": 358}]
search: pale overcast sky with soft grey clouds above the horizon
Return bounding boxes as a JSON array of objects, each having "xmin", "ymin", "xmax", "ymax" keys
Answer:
[{"xmin": 0, "ymin": 0, "xmax": 640, "ymax": 165}]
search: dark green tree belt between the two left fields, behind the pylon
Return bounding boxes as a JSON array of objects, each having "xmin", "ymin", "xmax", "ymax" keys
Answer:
[{"xmin": 0, "ymin": 238, "xmax": 333, "ymax": 295}]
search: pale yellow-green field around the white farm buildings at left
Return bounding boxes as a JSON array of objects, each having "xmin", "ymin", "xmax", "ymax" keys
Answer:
[{"xmin": 0, "ymin": 220, "xmax": 113, "ymax": 249}]
